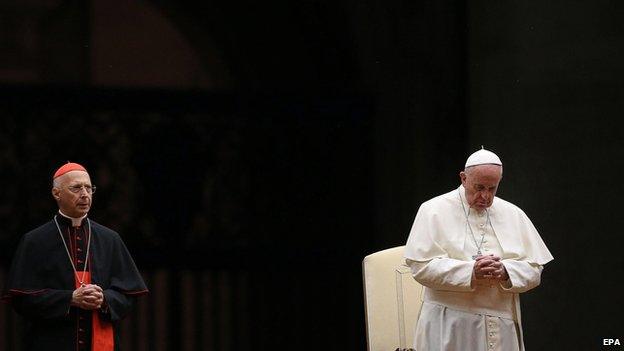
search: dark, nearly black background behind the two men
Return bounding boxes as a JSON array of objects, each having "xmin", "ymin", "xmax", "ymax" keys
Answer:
[{"xmin": 0, "ymin": 0, "xmax": 624, "ymax": 350}]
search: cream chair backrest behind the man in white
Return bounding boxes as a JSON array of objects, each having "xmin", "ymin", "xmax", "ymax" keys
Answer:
[{"xmin": 362, "ymin": 246, "xmax": 422, "ymax": 351}]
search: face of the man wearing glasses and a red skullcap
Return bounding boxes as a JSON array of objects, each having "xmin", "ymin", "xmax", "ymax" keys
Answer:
[{"xmin": 52, "ymin": 171, "xmax": 93, "ymax": 218}]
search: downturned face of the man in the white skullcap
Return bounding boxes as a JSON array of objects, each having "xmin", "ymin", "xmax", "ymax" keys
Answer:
[{"xmin": 459, "ymin": 165, "xmax": 503, "ymax": 211}]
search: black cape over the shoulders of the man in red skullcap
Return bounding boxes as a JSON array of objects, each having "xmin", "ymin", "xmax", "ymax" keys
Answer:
[{"xmin": 2, "ymin": 220, "xmax": 147, "ymax": 350}]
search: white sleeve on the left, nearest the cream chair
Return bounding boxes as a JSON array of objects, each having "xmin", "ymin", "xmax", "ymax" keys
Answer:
[{"xmin": 406, "ymin": 258, "xmax": 474, "ymax": 291}]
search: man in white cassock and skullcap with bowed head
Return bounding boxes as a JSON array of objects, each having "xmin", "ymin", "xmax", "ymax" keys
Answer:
[{"xmin": 405, "ymin": 149, "xmax": 553, "ymax": 351}]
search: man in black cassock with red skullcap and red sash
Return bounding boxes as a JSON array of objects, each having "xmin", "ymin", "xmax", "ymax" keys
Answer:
[{"xmin": 2, "ymin": 163, "xmax": 148, "ymax": 351}]
